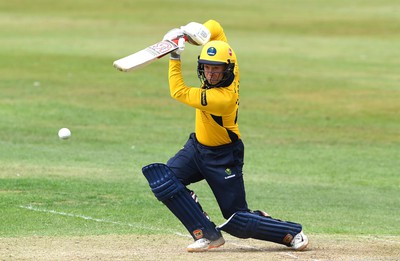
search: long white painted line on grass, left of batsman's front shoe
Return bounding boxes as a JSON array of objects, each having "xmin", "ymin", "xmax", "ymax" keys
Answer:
[{"xmin": 19, "ymin": 205, "xmax": 191, "ymax": 237}]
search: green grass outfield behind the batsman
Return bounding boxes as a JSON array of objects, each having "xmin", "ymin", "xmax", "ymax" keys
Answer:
[{"xmin": 0, "ymin": 0, "xmax": 400, "ymax": 256}]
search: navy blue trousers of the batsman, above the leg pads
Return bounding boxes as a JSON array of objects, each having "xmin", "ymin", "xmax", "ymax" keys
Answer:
[{"xmin": 167, "ymin": 133, "xmax": 249, "ymax": 219}]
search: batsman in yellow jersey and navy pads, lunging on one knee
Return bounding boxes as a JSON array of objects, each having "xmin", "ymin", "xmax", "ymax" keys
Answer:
[{"xmin": 142, "ymin": 20, "xmax": 308, "ymax": 252}]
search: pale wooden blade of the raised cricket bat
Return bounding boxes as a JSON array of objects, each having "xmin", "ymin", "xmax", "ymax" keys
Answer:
[{"xmin": 113, "ymin": 40, "xmax": 178, "ymax": 72}]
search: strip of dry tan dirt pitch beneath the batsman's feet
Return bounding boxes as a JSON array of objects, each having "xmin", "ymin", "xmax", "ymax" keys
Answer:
[{"xmin": 0, "ymin": 235, "xmax": 400, "ymax": 261}]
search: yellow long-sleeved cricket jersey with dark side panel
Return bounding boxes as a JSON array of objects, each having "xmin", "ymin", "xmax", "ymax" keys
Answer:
[{"xmin": 168, "ymin": 20, "xmax": 240, "ymax": 146}]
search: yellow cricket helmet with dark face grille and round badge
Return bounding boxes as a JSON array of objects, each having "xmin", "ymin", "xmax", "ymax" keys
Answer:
[{"xmin": 197, "ymin": 41, "xmax": 236, "ymax": 88}]
